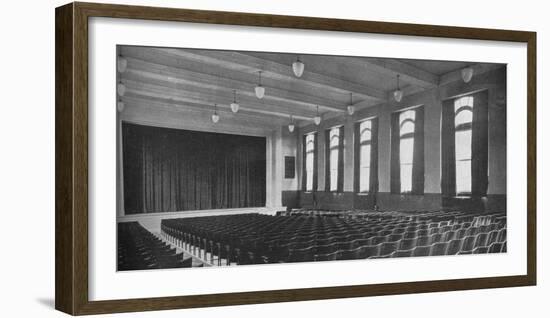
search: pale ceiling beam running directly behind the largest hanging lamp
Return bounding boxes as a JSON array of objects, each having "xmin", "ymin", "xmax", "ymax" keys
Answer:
[{"xmin": 157, "ymin": 48, "xmax": 386, "ymax": 100}]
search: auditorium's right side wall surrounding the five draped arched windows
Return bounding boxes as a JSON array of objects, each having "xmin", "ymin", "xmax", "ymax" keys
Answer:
[{"xmin": 293, "ymin": 66, "xmax": 506, "ymax": 210}]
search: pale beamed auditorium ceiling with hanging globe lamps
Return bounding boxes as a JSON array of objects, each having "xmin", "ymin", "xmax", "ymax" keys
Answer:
[{"xmin": 118, "ymin": 46, "xmax": 502, "ymax": 130}]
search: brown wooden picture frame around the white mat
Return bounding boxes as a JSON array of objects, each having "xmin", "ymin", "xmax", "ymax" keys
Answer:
[{"xmin": 55, "ymin": 2, "xmax": 536, "ymax": 315}]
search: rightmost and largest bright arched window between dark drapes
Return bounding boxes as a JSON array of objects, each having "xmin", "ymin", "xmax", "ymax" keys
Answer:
[{"xmin": 454, "ymin": 96, "xmax": 474, "ymax": 195}]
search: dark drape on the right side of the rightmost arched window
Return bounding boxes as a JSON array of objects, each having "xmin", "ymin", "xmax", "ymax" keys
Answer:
[{"xmin": 472, "ymin": 90, "xmax": 489, "ymax": 196}]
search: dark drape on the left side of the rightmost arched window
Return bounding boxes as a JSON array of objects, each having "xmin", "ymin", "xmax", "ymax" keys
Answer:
[{"xmin": 441, "ymin": 99, "xmax": 456, "ymax": 196}]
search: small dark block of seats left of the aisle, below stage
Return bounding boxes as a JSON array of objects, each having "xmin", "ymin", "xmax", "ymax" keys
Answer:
[{"xmin": 117, "ymin": 222, "xmax": 192, "ymax": 271}]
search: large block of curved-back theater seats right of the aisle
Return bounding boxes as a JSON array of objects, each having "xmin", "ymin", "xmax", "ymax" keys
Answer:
[{"xmin": 161, "ymin": 211, "xmax": 506, "ymax": 265}]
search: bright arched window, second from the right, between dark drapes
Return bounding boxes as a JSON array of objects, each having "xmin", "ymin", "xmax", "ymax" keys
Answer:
[{"xmin": 399, "ymin": 110, "xmax": 416, "ymax": 193}]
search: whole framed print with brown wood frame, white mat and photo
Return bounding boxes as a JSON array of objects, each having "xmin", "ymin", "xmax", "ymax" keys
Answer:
[{"xmin": 56, "ymin": 3, "xmax": 536, "ymax": 315}]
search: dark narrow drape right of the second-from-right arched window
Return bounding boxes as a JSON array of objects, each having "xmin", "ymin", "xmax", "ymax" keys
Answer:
[{"xmin": 411, "ymin": 106, "xmax": 424, "ymax": 194}]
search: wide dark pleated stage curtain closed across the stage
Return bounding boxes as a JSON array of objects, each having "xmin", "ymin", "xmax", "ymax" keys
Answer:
[{"xmin": 122, "ymin": 123, "xmax": 266, "ymax": 214}]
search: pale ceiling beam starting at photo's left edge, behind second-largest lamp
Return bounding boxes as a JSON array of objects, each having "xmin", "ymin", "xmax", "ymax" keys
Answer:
[{"xmin": 121, "ymin": 57, "xmax": 345, "ymax": 112}]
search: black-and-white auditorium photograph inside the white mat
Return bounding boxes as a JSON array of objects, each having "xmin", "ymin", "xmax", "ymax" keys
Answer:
[{"xmin": 113, "ymin": 45, "xmax": 507, "ymax": 271}]
